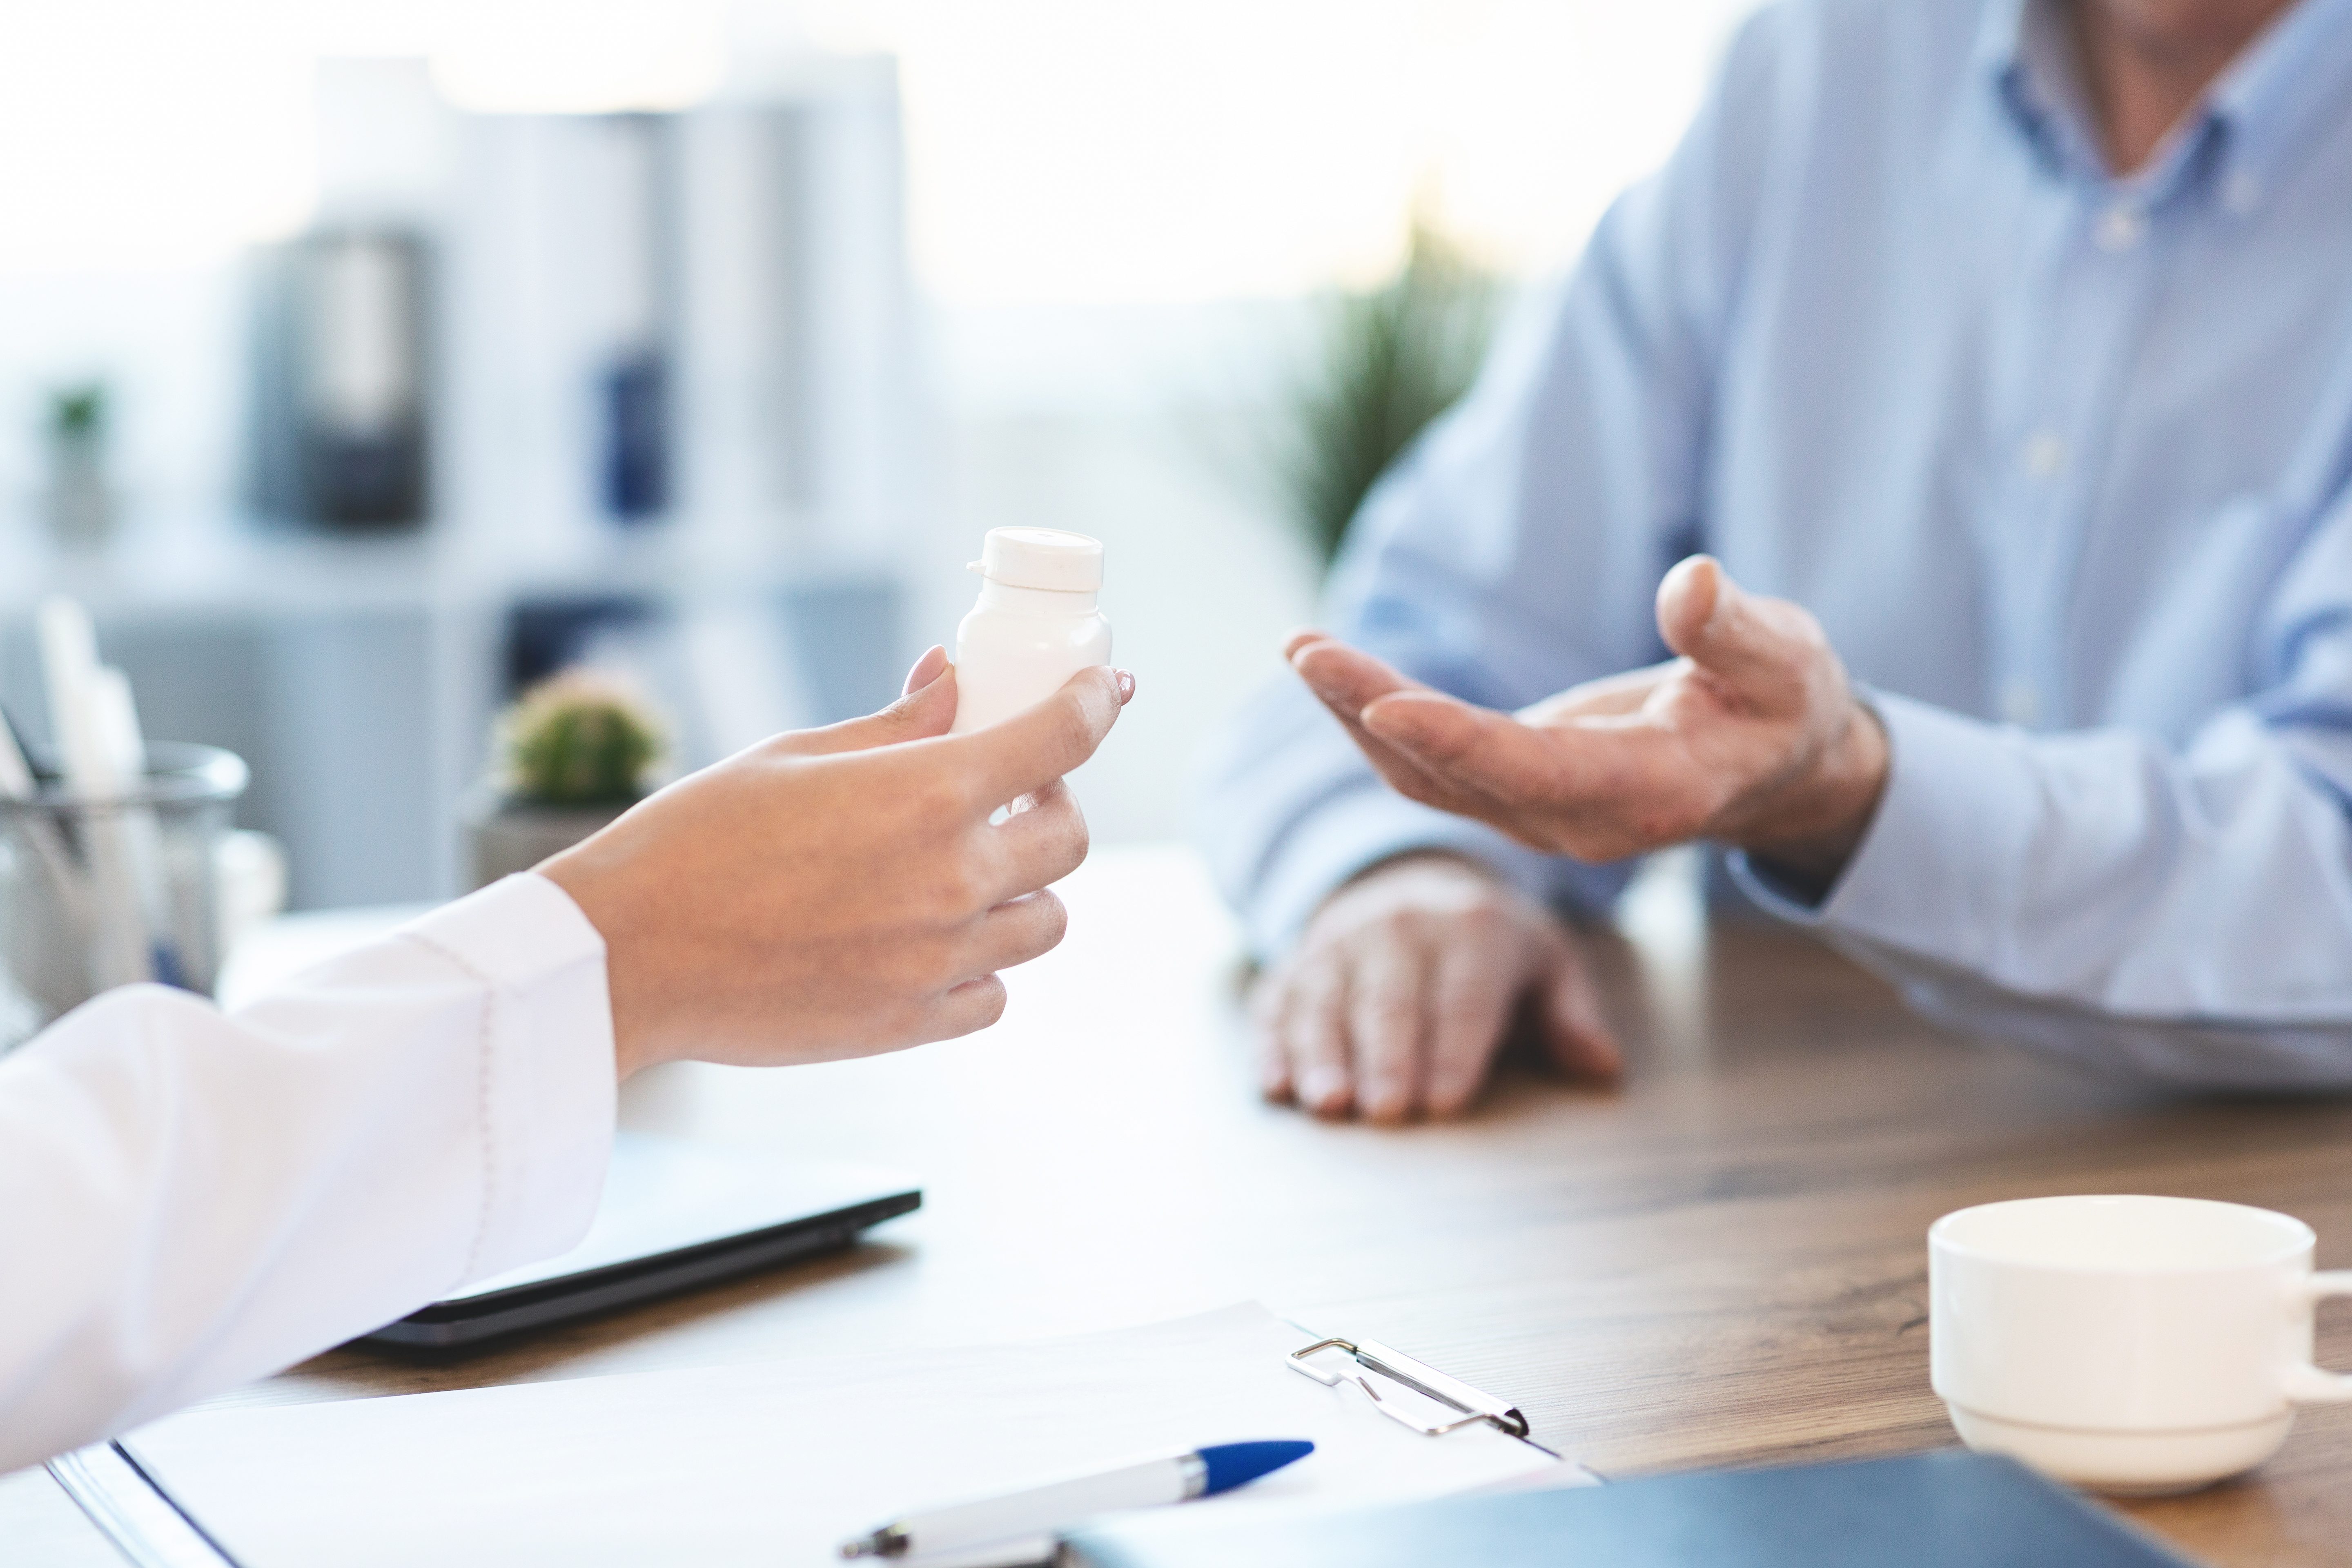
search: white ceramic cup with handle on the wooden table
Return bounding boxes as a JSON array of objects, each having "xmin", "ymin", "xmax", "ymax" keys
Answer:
[{"xmin": 1926, "ymin": 1196, "xmax": 2352, "ymax": 1493}]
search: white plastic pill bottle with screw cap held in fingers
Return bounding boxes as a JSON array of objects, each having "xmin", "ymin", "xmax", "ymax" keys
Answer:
[{"xmin": 948, "ymin": 529, "xmax": 1110, "ymax": 736}]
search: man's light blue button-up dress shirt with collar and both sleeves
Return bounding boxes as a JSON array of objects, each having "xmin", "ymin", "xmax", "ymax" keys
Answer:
[{"xmin": 1202, "ymin": 0, "xmax": 2352, "ymax": 1086}]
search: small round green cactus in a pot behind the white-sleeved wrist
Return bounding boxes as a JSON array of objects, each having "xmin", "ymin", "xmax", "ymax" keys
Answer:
[{"xmin": 466, "ymin": 670, "xmax": 666, "ymax": 886}]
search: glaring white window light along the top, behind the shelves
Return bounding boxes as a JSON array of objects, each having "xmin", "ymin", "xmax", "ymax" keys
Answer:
[{"xmin": 0, "ymin": 0, "xmax": 1752, "ymax": 303}]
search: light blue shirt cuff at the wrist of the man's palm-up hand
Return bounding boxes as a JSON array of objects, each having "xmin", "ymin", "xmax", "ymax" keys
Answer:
[{"xmin": 1729, "ymin": 693, "xmax": 2042, "ymax": 973}]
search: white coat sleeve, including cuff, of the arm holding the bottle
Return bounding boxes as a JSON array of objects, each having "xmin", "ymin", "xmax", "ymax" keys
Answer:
[{"xmin": 0, "ymin": 875, "xmax": 614, "ymax": 1472}]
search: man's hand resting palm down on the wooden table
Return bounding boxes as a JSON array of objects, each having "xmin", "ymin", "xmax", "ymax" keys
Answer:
[{"xmin": 1251, "ymin": 851, "xmax": 1618, "ymax": 1124}]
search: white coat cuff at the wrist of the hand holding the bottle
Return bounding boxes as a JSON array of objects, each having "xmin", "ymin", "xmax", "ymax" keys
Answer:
[{"xmin": 400, "ymin": 872, "xmax": 616, "ymax": 1281}]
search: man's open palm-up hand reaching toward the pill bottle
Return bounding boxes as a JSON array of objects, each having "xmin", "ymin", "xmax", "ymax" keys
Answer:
[{"xmin": 1287, "ymin": 555, "xmax": 1886, "ymax": 891}]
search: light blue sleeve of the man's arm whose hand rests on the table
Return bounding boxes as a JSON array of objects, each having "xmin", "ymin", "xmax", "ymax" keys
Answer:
[{"xmin": 1197, "ymin": 12, "xmax": 1780, "ymax": 957}]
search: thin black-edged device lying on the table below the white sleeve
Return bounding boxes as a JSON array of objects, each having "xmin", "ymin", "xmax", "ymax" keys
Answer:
[{"xmin": 355, "ymin": 1133, "xmax": 922, "ymax": 1350}]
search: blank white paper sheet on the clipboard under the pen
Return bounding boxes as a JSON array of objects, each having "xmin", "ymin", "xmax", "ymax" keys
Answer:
[{"xmin": 125, "ymin": 1305, "xmax": 1573, "ymax": 1568}]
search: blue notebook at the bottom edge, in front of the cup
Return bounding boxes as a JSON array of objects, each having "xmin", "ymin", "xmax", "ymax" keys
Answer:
[{"xmin": 1061, "ymin": 1450, "xmax": 2187, "ymax": 1568}]
